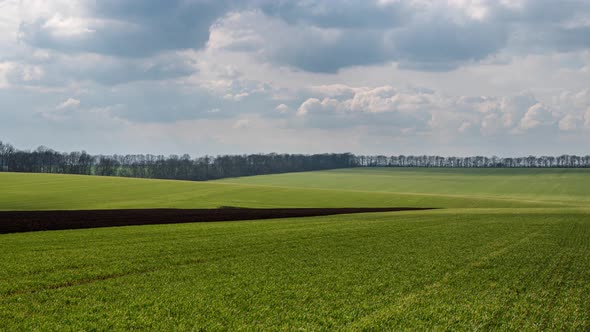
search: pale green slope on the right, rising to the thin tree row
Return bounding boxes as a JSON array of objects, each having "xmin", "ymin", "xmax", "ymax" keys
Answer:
[{"xmin": 218, "ymin": 168, "xmax": 590, "ymax": 205}]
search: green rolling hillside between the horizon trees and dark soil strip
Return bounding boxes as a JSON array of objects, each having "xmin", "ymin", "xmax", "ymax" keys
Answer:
[{"xmin": 0, "ymin": 169, "xmax": 590, "ymax": 210}]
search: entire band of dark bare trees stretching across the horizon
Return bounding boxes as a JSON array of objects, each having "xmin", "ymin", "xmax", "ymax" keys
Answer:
[{"xmin": 0, "ymin": 141, "xmax": 590, "ymax": 181}]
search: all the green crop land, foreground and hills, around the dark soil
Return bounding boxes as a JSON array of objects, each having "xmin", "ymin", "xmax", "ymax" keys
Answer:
[{"xmin": 0, "ymin": 169, "xmax": 590, "ymax": 331}]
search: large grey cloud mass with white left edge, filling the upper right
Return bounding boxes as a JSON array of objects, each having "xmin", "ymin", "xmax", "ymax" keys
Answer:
[{"xmin": 212, "ymin": 1, "xmax": 590, "ymax": 73}]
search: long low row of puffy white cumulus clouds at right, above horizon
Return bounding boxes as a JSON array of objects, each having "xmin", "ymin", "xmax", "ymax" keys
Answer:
[{"xmin": 297, "ymin": 85, "xmax": 584, "ymax": 137}]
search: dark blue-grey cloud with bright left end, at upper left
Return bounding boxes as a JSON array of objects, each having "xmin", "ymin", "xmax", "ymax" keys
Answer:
[{"xmin": 19, "ymin": 0, "xmax": 237, "ymax": 58}]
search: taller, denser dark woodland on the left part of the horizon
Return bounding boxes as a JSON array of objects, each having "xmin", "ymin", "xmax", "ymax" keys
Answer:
[{"xmin": 0, "ymin": 141, "xmax": 355, "ymax": 181}]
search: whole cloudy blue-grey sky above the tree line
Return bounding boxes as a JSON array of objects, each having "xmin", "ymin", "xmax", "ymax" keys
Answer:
[{"xmin": 0, "ymin": 0, "xmax": 590, "ymax": 156}]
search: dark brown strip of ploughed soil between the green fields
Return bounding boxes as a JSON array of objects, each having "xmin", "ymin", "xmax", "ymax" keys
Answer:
[{"xmin": 0, "ymin": 207, "xmax": 434, "ymax": 234}]
